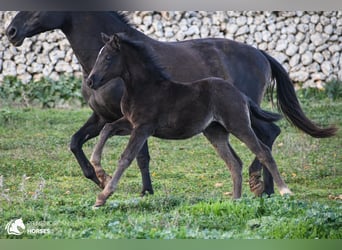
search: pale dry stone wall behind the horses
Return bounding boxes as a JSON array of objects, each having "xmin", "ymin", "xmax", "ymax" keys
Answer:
[{"xmin": 0, "ymin": 11, "xmax": 342, "ymax": 87}]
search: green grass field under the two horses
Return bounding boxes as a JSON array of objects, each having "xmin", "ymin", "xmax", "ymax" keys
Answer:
[{"xmin": 0, "ymin": 95, "xmax": 342, "ymax": 239}]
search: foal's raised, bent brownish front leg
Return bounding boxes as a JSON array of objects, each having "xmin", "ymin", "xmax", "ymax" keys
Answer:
[{"xmin": 90, "ymin": 118, "xmax": 132, "ymax": 188}]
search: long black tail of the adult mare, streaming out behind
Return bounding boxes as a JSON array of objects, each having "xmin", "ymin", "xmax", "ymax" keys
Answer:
[{"xmin": 260, "ymin": 50, "xmax": 337, "ymax": 138}]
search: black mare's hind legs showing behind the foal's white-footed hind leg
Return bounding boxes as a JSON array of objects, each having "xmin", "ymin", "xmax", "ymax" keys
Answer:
[{"xmin": 249, "ymin": 119, "xmax": 280, "ymax": 196}]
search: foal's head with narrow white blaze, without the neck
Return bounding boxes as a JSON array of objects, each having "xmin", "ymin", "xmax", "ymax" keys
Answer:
[{"xmin": 87, "ymin": 33, "xmax": 124, "ymax": 89}]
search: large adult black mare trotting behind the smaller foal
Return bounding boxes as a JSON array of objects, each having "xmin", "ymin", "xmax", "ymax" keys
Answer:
[{"xmin": 6, "ymin": 12, "xmax": 335, "ymax": 194}]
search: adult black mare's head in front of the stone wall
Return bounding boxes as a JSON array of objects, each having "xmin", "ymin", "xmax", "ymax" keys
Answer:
[{"xmin": 6, "ymin": 11, "xmax": 67, "ymax": 46}]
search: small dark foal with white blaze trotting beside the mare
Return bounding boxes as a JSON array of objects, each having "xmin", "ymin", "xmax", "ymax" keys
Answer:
[{"xmin": 87, "ymin": 33, "xmax": 291, "ymax": 207}]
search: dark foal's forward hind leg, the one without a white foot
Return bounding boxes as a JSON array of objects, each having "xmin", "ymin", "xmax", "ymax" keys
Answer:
[{"xmin": 203, "ymin": 124, "xmax": 242, "ymax": 199}]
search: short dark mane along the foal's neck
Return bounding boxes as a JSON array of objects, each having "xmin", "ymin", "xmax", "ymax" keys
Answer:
[{"xmin": 120, "ymin": 33, "xmax": 170, "ymax": 80}]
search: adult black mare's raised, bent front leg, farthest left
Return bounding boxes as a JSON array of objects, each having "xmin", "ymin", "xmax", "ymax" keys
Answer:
[{"xmin": 70, "ymin": 113, "xmax": 105, "ymax": 188}]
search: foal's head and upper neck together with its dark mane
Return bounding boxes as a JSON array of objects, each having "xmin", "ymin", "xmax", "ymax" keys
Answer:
[{"xmin": 87, "ymin": 33, "xmax": 170, "ymax": 89}]
